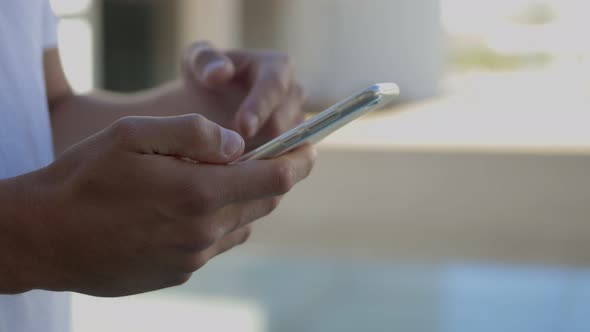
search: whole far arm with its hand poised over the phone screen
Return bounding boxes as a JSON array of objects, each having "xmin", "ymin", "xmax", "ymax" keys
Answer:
[{"xmin": 44, "ymin": 43, "xmax": 304, "ymax": 154}]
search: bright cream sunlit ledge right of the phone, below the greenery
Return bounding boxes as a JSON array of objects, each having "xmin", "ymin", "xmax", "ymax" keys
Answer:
[{"xmin": 323, "ymin": 70, "xmax": 590, "ymax": 152}]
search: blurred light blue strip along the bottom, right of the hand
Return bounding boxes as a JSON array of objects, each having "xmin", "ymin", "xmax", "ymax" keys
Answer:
[{"xmin": 167, "ymin": 255, "xmax": 590, "ymax": 332}]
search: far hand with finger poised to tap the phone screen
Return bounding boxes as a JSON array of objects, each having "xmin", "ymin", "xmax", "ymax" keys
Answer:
[{"xmin": 182, "ymin": 42, "xmax": 305, "ymax": 148}]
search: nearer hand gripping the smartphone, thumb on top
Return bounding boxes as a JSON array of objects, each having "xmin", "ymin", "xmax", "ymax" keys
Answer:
[{"xmin": 6, "ymin": 114, "xmax": 314, "ymax": 296}]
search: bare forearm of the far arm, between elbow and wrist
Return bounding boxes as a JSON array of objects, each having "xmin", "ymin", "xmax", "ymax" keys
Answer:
[{"xmin": 50, "ymin": 82, "xmax": 196, "ymax": 154}]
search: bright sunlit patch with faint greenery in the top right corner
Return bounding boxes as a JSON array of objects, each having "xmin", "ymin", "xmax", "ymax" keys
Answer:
[{"xmin": 441, "ymin": 0, "xmax": 590, "ymax": 67}]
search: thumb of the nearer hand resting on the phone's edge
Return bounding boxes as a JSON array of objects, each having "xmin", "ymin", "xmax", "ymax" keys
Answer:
[{"xmin": 112, "ymin": 114, "xmax": 244, "ymax": 164}]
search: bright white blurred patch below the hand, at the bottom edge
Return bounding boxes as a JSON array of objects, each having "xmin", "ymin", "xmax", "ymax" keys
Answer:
[{"xmin": 72, "ymin": 294, "xmax": 267, "ymax": 332}]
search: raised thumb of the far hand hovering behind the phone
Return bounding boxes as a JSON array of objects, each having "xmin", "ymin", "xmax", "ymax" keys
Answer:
[{"xmin": 184, "ymin": 42, "xmax": 236, "ymax": 87}]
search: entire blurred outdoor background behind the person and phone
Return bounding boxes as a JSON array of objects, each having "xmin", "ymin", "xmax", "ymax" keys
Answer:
[{"xmin": 52, "ymin": 0, "xmax": 590, "ymax": 332}]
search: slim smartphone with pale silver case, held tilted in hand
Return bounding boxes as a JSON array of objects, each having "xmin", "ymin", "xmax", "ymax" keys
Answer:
[{"xmin": 236, "ymin": 83, "xmax": 399, "ymax": 162}]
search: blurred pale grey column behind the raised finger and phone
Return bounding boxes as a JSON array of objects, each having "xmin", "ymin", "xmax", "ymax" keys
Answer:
[{"xmin": 245, "ymin": 0, "xmax": 444, "ymax": 103}]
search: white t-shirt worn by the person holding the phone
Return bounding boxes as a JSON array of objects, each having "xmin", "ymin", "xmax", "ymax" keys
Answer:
[{"xmin": 0, "ymin": 0, "xmax": 70, "ymax": 332}]
